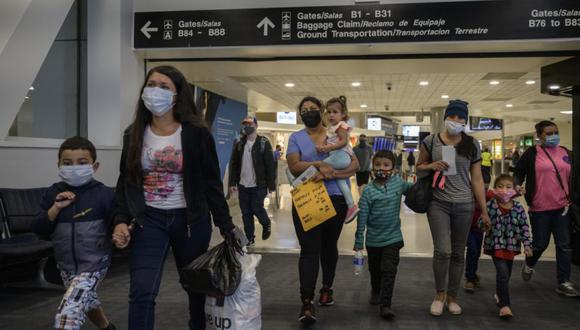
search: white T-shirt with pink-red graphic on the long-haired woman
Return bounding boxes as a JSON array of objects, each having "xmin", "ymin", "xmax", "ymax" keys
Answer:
[{"xmin": 141, "ymin": 125, "xmax": 186, "ymax": 210}]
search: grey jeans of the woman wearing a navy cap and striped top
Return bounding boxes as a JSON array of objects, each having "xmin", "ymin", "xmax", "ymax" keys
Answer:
[{"xmin": 427, "ymin": 199, "xmax": 473, "ymax": 297}]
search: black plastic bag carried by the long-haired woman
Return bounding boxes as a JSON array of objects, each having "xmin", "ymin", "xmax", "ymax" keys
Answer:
[{"xmin": 179, "ymin": 236, "xmax": 243, "ymax": 297}]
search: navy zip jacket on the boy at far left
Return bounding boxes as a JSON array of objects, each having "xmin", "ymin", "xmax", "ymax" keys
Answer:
[{"xmin": 32, "ymin": 180, "xmax": 114, "ymax": 274}]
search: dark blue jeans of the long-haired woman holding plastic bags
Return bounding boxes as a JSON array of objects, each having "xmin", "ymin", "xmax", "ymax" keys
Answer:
[{"xmin": 129, "ymin": 207, "xmax": 211, "ymax": 330}]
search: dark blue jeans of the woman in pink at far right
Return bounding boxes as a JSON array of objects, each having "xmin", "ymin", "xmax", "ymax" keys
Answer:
[{"xmin": 526, "ymin": 209, "xmax": 572, "ymax": 283}]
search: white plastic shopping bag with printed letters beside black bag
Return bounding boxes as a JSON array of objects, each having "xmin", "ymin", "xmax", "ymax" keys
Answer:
[{"xmin": 205, "ymin": 253, "xmax": 262, "ymax": 330}]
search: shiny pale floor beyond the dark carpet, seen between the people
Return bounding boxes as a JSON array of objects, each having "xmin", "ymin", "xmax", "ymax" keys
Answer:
[{"xmin": 219, "ymin": 180, "xmax": 555, "ymax": 260}]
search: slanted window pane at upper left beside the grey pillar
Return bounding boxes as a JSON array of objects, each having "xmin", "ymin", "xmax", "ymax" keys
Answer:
[{"xmin": 9, "ymin": 0, "xmax": 86, "ymax": 139}]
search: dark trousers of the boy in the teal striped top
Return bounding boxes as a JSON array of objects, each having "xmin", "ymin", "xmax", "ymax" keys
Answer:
[{"xmin": 366, "ymin": 241, "xmax": 404, "ymax": 307}]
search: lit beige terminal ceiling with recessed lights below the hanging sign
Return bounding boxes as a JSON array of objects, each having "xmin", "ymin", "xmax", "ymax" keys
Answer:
[{"xmin": 148, "ymin": 57, "xmax": 572, "ymax": 122}]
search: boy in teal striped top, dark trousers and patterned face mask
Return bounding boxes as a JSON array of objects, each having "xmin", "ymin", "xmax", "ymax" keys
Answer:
[{"xmin": 354, "ymin": 150, "xmax": 413, "ymax": 320}]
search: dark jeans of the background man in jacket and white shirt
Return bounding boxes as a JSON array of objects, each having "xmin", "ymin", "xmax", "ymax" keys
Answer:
[{"xmin": 238, "ymin": 185, "xmax": 270, "ymax": 241}]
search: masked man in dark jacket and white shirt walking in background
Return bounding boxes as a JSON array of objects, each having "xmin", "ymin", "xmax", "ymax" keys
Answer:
[{"xmin": 229, "ymin": 116, "xmax": 276, "ymax": 245}]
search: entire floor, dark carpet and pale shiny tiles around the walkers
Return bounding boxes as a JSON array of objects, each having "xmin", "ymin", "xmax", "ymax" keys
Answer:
[{"xmin": 0, "ymin": 180, "xmax": 568, "ymax": 330}]
